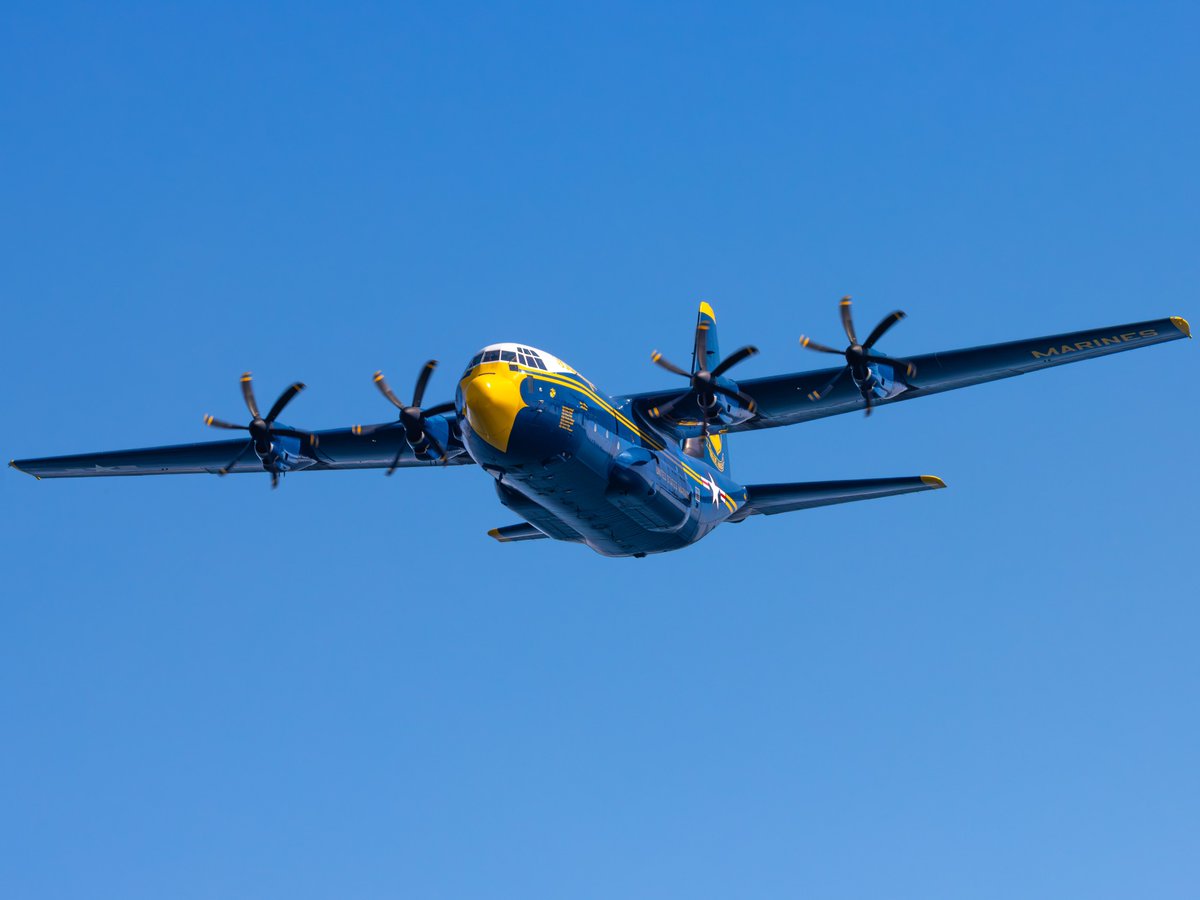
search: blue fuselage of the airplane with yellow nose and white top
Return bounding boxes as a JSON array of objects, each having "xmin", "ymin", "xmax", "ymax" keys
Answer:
[{"xmin": 456, "ymin": 344, "xmax": 745, "ymax": 557}]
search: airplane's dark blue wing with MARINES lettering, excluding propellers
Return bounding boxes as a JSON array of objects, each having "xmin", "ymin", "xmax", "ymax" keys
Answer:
[{"xmin": 628, "ymin": 316, "xmax": 1192, "ymax": 432}]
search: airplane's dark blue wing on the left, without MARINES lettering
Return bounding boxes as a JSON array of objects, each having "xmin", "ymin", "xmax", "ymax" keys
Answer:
[{"xmin": 8, "ymin": 427, "xmax": 473, "ymax": 479}]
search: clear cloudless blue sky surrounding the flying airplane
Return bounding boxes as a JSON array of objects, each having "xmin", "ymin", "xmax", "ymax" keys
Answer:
[{"xmin": 0, "ymin": 2, "xmax": 1200, "ymax": 900}]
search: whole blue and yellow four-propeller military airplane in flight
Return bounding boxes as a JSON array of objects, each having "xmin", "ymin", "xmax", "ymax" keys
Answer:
[{"xmin": 10, "ymin": 298, "xmax": 1192, "ymax": 558}]
